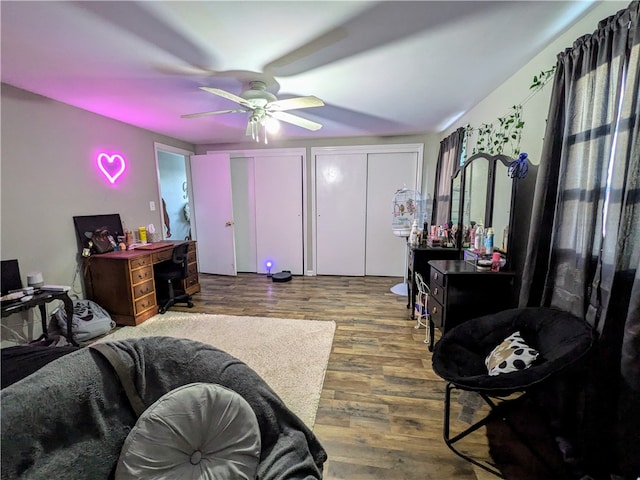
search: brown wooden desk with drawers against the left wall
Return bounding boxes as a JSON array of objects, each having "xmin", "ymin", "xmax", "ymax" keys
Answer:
[{"xmin": 84, "ymin": 241, "xmax": 200, "ymax": 326}]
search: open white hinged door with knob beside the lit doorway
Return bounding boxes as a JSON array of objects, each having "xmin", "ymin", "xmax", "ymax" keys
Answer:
[{"xmin": 191, "ymin": 153, "xmax": 237, "ymax": 275}]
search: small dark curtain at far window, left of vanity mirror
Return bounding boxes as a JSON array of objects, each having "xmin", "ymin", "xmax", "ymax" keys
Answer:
[{"xmin": 431, "ymin": 128, "xmax": 464, "ymax": 225}]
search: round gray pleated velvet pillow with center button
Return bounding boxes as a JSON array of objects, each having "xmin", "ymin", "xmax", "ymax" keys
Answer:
[{"xmin": 115, "ymin": 383, "xmax": 260, "ymax": 480}]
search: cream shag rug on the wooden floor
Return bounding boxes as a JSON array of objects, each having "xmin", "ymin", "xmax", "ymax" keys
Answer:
[{"xmin": 98, "ymin": 312, "xmax": 336, "ymax": 428}]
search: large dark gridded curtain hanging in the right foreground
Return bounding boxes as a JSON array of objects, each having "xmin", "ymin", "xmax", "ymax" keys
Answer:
[{"xmin": 520, "ymin": 1, "xmax": 640, "ymax": 478}]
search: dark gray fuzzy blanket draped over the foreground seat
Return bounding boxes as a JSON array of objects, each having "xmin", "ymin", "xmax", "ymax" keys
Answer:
[{"xmin": 0, "ymin": 337, "xmax": 327, "ymax": 480}]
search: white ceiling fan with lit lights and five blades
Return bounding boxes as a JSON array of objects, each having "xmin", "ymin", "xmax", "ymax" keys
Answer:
[{"xmin": 182, "ymin": 81, "xmax": 324, "ymax": 143}]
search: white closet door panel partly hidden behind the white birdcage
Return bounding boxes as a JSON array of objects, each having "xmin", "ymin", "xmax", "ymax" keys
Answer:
[{"xmin": 365, "ymin": 152, "xmax": 418, "ymax": 277}]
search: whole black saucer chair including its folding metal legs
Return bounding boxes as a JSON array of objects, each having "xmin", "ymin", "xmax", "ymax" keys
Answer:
[{"xmin": 432, "ymin": 308, "xmax": 593, "ymax": 477}]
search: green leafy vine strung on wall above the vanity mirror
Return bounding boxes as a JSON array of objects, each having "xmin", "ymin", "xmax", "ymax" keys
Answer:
[{"xmin": 466, "ymin": 66, "xmax": 556, "ymax": 157}]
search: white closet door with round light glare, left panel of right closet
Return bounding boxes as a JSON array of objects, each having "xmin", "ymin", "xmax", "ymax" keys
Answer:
[{"xmin": 315, "ymin": 153, "xmax": 367, "ymax": 276}]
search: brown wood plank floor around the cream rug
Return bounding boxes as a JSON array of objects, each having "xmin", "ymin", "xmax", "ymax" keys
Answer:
[{"xmin": 172, "ymin": 273, "xmax": 495, "ymax": 480}]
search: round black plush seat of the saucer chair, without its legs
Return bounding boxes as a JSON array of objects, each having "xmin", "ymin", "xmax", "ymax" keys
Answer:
[{"xmin": 432, "ymin": 307, "xmax": 593, "ymax": 393}]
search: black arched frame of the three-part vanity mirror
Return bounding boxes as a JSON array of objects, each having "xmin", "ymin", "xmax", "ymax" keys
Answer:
[{"xmin": 449, "ymin": 152, "xmax": 517, "ymax": 268}]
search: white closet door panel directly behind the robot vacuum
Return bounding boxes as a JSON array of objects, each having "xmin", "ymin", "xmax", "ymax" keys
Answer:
[{"xmin": 254, "ymin": 155, "xmax": 303, "ymax": 275}]
